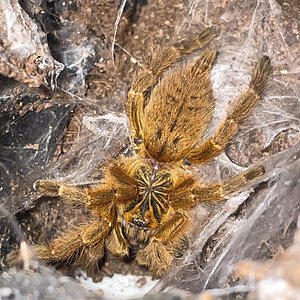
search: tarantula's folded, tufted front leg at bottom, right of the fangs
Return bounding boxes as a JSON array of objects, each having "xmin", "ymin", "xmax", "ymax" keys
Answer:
[{"xmin": 136, "ymin": 213, "xmax": 189, "ymax": 277}]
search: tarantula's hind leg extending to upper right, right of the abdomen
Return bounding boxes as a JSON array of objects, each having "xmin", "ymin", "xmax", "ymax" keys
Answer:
[{"xmin": 187, "ymin": 56, "xmax": 271, "ymax": 164}]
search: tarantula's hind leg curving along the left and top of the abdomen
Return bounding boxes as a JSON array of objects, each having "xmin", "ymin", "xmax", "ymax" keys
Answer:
[{"xmin": 127, "ymin": 28, "xmax": 217, "ymax": 151}]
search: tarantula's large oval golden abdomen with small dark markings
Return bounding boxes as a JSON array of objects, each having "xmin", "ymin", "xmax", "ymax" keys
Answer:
[{"xmin": 143, "ymin": 63, "xmax": 215, "ymax": 162}]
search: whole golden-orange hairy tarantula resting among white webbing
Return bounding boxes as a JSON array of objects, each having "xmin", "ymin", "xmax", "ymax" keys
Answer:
[{"xmin": 35, "ymin": 28, "xmax": 271, "ymax": 276}]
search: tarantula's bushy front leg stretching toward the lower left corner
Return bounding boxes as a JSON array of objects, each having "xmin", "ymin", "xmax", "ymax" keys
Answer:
[{"xmin": 34, "ymin": 221, "xmax": 111, "ymax": 266}]
